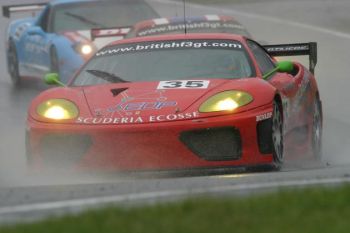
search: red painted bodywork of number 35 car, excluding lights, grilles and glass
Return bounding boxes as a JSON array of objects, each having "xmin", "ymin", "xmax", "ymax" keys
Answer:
[{"xmin": 27, "ymin": 34, "xmax": 318, "ymax": 170}]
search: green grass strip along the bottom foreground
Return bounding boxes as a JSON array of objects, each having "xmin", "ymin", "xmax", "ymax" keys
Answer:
[{"xmin": 0, "ymin": 186, "xmax": 350, "ymax": 233}]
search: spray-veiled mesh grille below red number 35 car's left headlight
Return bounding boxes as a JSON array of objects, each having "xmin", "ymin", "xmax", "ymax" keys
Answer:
[{"xmin": 40, "ymin": 134, "xmax": 92, "ymax": 167}]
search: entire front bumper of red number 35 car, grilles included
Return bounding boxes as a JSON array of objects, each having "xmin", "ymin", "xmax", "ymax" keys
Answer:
[{"xmin": 27, "ymin": 105, "xmax": 273, "ymax": 171}]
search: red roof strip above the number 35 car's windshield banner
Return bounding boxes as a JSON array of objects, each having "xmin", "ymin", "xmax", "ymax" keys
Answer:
[{"xmin": 107, "ymin": 33, "xmax": 246, "ymax": 47}]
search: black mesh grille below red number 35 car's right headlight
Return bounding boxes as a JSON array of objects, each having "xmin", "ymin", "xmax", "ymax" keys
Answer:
[{"xmin": 180, "ymin": 127, "xmax": 242, "ymax": 161}]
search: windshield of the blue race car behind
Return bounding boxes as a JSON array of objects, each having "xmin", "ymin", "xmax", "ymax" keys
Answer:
[{"xmin": 52, "ymin": 0, "xmax": 158, "ymax": 32}]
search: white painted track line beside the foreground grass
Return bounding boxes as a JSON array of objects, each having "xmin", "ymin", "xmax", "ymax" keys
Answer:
[{"xmin": 0, "ymin": 177, "xmax": 350, "ymax": 217}]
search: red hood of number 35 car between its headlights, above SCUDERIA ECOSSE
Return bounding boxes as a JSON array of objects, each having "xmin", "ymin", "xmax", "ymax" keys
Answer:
[{"xmin": 80, "ymin": 80, "xmax": 229, "ymax": 122}]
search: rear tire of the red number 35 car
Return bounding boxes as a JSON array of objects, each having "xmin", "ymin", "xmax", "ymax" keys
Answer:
[{"xmin": 311, "ymin": 96, "xmax": 323, "ymax": 160}]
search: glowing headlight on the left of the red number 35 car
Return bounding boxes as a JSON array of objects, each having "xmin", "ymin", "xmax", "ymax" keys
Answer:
[{"xmin": 36, "ymin": 99, "xmax": 79, "ymax": 120}]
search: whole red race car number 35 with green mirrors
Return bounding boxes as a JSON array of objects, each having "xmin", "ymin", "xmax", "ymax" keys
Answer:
[{"xmin": 26, "ymin": 33, "xmax": 322, "ymax": 171}]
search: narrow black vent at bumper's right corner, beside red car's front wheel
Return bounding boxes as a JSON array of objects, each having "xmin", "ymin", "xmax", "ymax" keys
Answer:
[{"xmin": 257, "ymin": 119, "xmax": 273, "ymax": 154}]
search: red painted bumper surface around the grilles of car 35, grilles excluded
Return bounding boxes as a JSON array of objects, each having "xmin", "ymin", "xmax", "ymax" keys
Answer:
[{"xmin": 29, "ymin": 106, "xmax": 272, "ymax": 171}]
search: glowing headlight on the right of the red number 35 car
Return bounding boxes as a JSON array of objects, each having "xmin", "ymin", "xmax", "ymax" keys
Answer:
[{"xmin": 199, "ymin": 91, "xmax": 253, "ymax": 112}]
